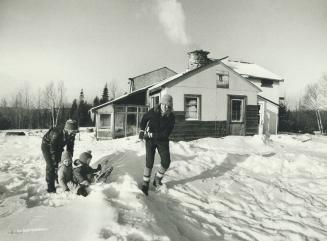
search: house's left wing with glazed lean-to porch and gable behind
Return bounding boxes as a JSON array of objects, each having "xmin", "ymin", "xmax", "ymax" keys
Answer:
[{"xmin": 90, "ymin": 67, "xmax": 176, "ymax": 139}]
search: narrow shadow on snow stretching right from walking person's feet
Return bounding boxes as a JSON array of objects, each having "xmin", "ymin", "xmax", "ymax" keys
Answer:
[{"xmin": 166, "ymin": 153, "xmax": 249, "ymax": 188}]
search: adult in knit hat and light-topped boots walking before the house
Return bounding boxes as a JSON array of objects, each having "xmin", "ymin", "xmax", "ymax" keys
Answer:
[{"xmin": 139, "ymin": 94, "xmax": 175, "ymax": 195}]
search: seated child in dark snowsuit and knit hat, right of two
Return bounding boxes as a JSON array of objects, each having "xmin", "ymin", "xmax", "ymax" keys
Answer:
[{"xmin": 73, "ymin": 151, "xmax": 101, "ymax": 197}]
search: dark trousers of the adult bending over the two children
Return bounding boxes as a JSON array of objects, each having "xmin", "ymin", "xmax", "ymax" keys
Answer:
[{"xmin": 41, "ymin": 144, "xmax": 58, "ymax": 192}]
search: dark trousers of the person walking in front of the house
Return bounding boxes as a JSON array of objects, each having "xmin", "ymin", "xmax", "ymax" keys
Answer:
[{"xmin": 145, "ymin": 140, "xmax": 170, "ymax": 170}]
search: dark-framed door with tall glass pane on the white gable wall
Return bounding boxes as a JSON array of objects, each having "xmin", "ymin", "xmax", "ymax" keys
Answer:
[{"xmin": 228, "ymin": 96, "xmax": 246, "ymax": 136}]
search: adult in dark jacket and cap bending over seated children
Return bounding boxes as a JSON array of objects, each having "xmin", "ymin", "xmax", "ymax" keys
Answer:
[{"xmin": 41, "ymin": 120, "xmax": 78, "ymax": 193}]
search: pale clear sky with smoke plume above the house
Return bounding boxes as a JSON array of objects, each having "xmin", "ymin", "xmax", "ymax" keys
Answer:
[{"xmin": 0, "ymin": 0, "xmax": 327, "ymax": 105}]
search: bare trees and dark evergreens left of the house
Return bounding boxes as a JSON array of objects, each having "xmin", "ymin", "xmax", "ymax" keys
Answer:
[{"xmin": 0, "ymin": 81, "xmax": 118, "ymax": 130}]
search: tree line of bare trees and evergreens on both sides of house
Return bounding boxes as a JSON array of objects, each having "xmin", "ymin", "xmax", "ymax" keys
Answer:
[{"xmin": 0, "ymin": 75, "xmax": 327, "ymax": 133}]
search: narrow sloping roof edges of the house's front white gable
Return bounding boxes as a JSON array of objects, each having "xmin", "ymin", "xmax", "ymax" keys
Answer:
[{"xmin": 149, "ymin": 56, "xmax": 261, "ymax": 92}]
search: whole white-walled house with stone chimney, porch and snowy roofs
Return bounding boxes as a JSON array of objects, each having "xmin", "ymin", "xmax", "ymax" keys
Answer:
[{"xmin": 92, "ymin": 50, "xmax": 283, "ymax": 140}]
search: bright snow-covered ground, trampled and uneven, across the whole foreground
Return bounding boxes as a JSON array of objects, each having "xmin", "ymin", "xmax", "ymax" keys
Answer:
[{"xmin": 0, "ymin": 131, "xmax": 327, "ymax": 241}]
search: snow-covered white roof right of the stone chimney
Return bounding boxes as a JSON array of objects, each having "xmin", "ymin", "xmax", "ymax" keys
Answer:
[{"xmin": 222, "ymin": 60, "xmax": 284, "ymax": 81}]
